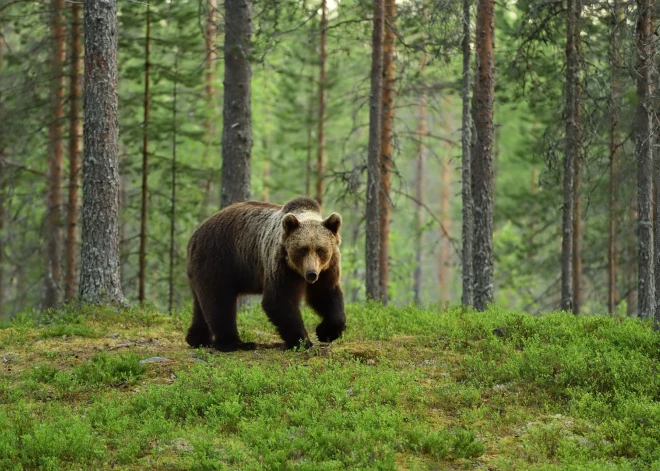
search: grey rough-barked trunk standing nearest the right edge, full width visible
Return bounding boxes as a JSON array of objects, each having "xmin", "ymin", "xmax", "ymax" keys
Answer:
[{"xmin": 635, "ymin": 0, "xmax": 655, "ymax": 318}]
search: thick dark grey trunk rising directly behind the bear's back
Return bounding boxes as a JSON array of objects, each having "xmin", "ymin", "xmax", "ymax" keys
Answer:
[{"xmin": 220, "ymin": 0, "xmax": 252, "ymax": 208}]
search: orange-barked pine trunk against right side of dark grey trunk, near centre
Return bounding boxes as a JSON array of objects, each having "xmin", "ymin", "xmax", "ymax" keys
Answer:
[{"xmin": 378, "ymin": 0, "xmax": 396, "ymax": 304}]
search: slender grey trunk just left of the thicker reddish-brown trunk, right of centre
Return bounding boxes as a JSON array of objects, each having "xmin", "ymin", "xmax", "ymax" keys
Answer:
[{"xmin": 461, "ymin": 0, "xmax": 474, "ymax": 307}]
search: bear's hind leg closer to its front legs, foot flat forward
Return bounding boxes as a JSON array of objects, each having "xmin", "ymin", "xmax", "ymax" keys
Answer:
[{"xmin": 201, "ymin": 291, "xmax": 257, "ymax": 352}]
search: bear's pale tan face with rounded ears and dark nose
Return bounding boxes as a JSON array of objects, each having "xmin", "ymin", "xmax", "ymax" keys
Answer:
[{"xmin": 282, "ymin": 213, "xmax": 341, "ymax": 284}]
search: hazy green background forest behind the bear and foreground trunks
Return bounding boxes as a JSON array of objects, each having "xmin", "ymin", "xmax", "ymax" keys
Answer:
[{"xmin": 0, "ymin": 0, "xmax": 658, "ymax": 318}]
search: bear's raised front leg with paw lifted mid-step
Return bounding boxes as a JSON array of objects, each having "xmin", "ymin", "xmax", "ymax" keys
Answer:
[{"xmin": 307, "ymin": 273, "xmax": 346, "ymax": 342}]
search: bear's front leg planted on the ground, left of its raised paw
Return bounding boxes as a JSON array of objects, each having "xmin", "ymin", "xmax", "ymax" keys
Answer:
[{"xmin": 261, "ymin": 279, "xmax": 312, "ymax": 349}]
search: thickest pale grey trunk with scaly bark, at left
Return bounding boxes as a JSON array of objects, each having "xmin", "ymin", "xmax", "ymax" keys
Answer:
[{"xmin": 80, "ymin": 0, "xmax": 125, "ymax": 303}]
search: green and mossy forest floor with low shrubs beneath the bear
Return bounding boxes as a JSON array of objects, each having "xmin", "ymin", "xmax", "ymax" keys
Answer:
[{"xmin": 0, "ymin": 304, "xmax": 660, "ymax": 470}]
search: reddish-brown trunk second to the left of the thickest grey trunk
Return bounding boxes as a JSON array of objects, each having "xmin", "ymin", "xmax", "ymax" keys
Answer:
[{"xmin": 44, "ymin": 0, "xmax": 65, "ymax": 308}]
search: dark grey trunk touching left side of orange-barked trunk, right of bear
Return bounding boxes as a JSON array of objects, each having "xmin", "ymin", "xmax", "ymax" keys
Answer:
[{"xmin": 365, "ymin": 0, "xmax": 384, "ymax": 301}]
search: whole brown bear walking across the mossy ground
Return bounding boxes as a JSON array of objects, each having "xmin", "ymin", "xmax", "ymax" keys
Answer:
[{"xmin": 186, "ymin": 197, "xmax": 346, "ymax": 352}]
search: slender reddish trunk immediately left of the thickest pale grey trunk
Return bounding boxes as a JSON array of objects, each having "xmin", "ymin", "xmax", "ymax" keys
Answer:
[{"xmin": 64, "ymin": 3, "xmax": 82, "ymax": 301}]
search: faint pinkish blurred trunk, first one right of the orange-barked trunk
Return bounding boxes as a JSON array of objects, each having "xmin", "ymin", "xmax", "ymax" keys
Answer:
[{"xmin": 413, "ymin": 72, "xmax": 426, "ymax": 305}]
